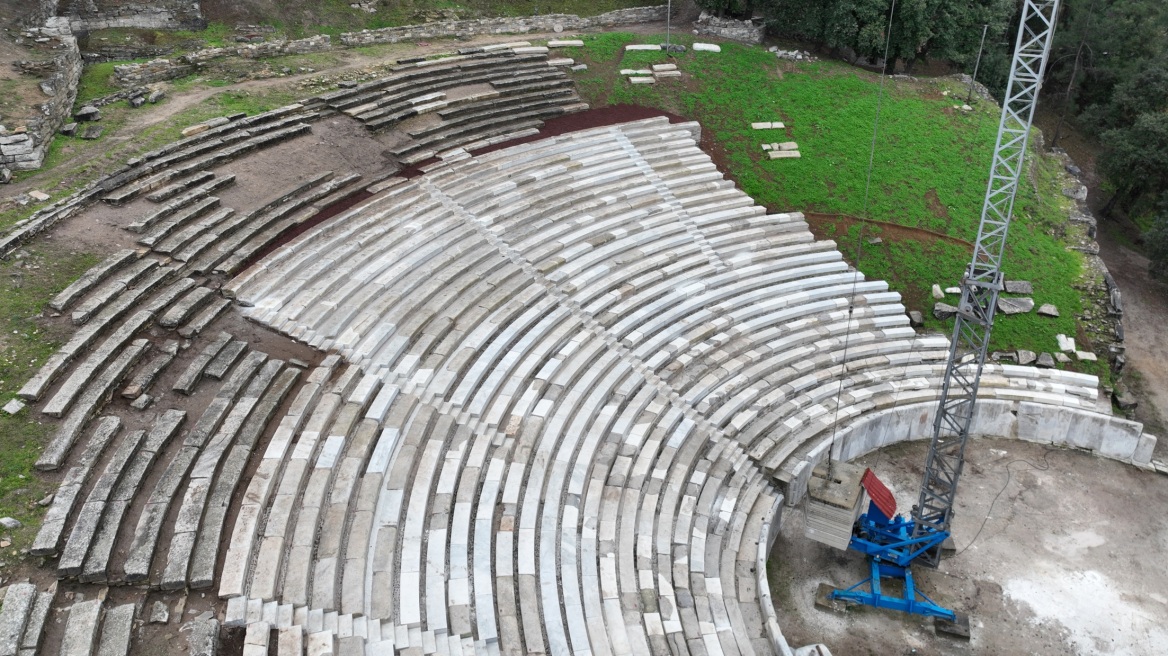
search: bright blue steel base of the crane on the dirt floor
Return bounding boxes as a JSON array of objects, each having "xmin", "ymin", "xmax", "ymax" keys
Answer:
[{"xmin": 816, "ymin": 503, "xmax": 969, "ymax": 640}]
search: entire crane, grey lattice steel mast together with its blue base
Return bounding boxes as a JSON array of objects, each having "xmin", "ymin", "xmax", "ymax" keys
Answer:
[{"xmin": 808, "ymin": 0, "xmax": 1059, "ymax": 635}]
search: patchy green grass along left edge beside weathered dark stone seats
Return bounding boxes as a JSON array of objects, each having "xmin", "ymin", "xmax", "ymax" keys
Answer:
[{"xmin": 0, "ymin": 244, "xmax": 99, "ymax": 550}]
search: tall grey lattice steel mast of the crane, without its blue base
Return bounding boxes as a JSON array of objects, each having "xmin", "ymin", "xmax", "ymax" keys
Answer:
[{"xmin": 912, "ymin": 0, "xmax": 1059, "ymax": 566}]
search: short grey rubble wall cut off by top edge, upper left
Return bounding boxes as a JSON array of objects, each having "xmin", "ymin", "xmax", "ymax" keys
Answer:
[{"xmin": 56, "ymin": 0, "xmax": 207, "ymax": 32}]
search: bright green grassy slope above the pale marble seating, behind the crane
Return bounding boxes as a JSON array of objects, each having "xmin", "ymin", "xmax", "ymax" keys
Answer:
[{"xmin": 579, "ymin": 33, "xmax": 1104, "ymax": 374}]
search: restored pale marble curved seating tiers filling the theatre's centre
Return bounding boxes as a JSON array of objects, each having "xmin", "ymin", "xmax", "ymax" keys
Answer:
[{"xmin": 218, "ymin": 118, "xmax": 1121, "ymax": 654}]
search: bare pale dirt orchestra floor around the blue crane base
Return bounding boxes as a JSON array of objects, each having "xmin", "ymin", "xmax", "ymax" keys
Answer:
[{"xmin": 770, "ymin": 440, "xmax": 1168, "ymax": 656}]
